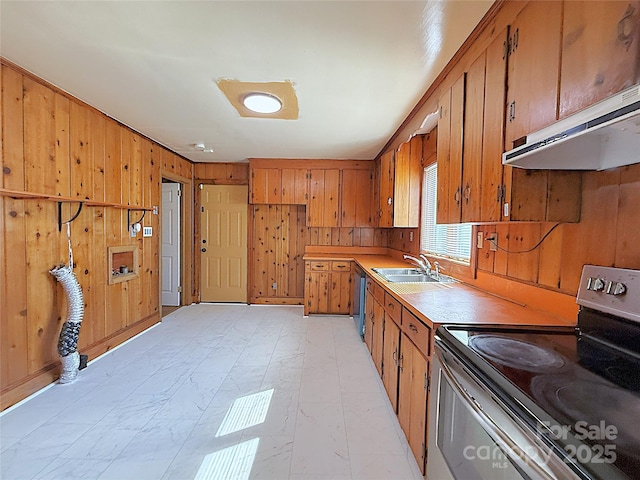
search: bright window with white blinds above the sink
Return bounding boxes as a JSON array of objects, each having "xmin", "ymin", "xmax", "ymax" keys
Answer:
[{"xmin": 420, "ymin": 163, "xmax": 471, "ymax": 263}]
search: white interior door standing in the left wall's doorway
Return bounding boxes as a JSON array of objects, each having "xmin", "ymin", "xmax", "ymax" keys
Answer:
[{"xmin": 162, "ymin": 183, "xmax": 181, "ymax": 306}]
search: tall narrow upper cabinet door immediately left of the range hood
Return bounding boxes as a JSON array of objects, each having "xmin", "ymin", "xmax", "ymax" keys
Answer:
[{"xmin": 480, "ymin": 29, "xmax": 511, "ymax": 222}]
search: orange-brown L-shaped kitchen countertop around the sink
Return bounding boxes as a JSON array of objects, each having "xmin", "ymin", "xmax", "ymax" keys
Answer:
[{"xmin": 305, "ymin": 254, "xmax": 577, "ymax": 328}]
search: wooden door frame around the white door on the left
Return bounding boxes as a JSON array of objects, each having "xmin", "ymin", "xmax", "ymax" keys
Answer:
[{"xmin": 158, "ymin": 171, "xmax": 194, "ymax": 306}]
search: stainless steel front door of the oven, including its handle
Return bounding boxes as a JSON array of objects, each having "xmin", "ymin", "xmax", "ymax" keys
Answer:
[{"xmin": 427, "ymin": 344, "xmax": 579, "ymax": 480}]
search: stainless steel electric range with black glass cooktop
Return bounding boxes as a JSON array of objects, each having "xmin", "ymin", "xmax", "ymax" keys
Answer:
[{"xmin": 427, "ymin": 265, "xmax": 640, "ymax": 480}]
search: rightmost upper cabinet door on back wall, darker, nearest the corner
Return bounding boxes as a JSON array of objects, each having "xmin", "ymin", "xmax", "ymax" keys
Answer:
[{"xmin": 340, "ymin": 169, "xmax": 373, "ymax": 227}]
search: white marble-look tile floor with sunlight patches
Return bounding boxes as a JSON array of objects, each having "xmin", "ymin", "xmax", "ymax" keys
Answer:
[{"xmin": 0, "ymin": 304, "xmax": 422, "ymax": 480}]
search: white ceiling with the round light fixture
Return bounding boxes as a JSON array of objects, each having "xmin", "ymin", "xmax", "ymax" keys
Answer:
[{"xmin": 0, "ymin": 0, "xmax": 493, "ymax": 162}]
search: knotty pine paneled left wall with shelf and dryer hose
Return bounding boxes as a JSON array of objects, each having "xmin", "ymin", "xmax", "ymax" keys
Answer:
[{"xmin": 0, "ymin": 61, "xmax": 193, "ymax": 409}]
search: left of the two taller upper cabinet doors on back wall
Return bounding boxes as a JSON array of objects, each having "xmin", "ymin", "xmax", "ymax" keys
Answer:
[{"xmin": 307, "ymin": 169, "xmax": 340, "ymax": 227}]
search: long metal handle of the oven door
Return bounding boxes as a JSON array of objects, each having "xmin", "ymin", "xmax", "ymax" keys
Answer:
[{"xmin": 436, "ymin": 353, "xmax": 556, "ymax": 480}]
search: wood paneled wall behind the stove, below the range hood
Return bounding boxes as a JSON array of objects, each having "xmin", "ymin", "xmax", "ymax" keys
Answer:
[{"xmin": 478, "ymin": 164, "xmax": 640, "ymax": 295}]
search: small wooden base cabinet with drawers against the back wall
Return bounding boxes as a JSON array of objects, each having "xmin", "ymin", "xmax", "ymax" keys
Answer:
[{"xmin": 304, "ymin": 260, "xmax": 352, "ymax": 315}]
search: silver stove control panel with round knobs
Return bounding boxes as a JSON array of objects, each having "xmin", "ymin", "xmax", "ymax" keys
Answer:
[{"xmin": 577, "ymin": 265, "xmax": 640, "ymax": 322}]
